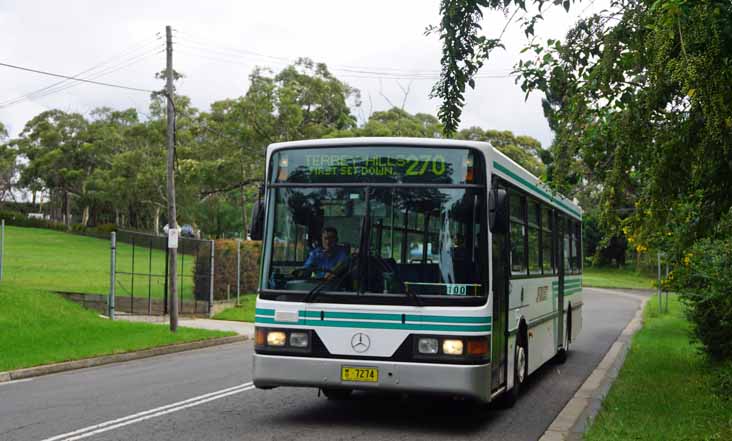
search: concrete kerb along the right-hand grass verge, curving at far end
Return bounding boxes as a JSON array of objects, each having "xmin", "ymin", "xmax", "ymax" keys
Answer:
[{"xmin": 539, "ymin": 288, "xmax": 650, "ymax": 441}]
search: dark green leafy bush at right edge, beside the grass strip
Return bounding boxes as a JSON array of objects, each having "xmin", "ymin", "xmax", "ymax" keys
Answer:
[{"xmin": 667, "ymin": 210, "xmax": 732, "ymax": 360}]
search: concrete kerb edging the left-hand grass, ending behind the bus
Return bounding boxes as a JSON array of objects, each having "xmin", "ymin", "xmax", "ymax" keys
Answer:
[{"xmin": 0, "ymin": 335, "xmax": 249, "ymax": 383}]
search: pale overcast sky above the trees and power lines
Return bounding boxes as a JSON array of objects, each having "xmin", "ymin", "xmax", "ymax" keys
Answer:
[{"xmin": 0, "ymin": 0, "xmax": 596, "ymax": 147}]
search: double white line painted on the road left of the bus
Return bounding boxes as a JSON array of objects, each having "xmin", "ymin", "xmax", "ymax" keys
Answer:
[{"xmin": 42, "ymin": 381, "xmax": 254, "ymax": 441}]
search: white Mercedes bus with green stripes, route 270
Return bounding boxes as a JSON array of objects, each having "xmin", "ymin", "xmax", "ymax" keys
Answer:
[{"xmin": 251, "ymin": 138, "xmax": 582, "ymax": 405}]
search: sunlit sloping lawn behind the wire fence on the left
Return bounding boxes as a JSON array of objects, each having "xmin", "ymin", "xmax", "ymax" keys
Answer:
[{"xmin": 3, "ymin": 226, "xmax": 195, "ymax": 300}]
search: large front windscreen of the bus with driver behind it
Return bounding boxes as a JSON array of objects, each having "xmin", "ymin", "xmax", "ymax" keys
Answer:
[{"xmin": 263, "ymin": 148, "xmax": 487, "ymax": 305}]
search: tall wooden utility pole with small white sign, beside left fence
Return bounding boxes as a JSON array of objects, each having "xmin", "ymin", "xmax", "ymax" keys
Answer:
[{"xmin": 165, "ymin": 26, "xmax": 178, "ymax": 332}]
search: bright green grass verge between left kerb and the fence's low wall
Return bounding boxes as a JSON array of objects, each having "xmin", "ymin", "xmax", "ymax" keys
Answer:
[{"xmin": 0, "ymin": 280, "xmax": 234, "ymax": 372}]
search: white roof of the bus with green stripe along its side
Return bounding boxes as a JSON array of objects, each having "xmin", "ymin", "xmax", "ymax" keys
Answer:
[{"xmin": 267, "ymin": 137, "xmax": 582, "ymax": 219}]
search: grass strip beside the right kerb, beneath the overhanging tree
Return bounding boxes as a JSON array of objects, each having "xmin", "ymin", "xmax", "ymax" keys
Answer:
[{"xmin": 584, "ymin": 296, "xmax": 732, "ymax": 441}]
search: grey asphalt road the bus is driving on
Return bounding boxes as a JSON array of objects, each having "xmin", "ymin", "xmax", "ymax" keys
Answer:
[{"xmin": 0, "ymin": 289, "xmax": 639, "ymax": 441}]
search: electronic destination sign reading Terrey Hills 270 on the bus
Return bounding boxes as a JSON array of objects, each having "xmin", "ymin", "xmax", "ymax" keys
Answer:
[{"xmin": 271, "ymin": 147, "xmax": 474, "ymax": 184}]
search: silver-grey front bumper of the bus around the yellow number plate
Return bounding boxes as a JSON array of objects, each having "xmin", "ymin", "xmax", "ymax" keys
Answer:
[{"xmin": 254, "ymin": 354, "xmax": 491, "ymax": 401}]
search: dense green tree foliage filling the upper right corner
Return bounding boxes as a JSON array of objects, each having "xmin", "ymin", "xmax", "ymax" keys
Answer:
[{"xmin": 518, "ymin": 0, "xmax": 732, "ymax": 259}]
